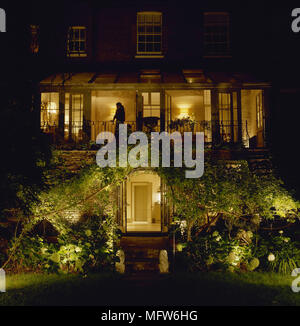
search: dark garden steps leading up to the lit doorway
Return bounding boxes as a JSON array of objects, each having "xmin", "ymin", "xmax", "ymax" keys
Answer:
[{"xmin": 120, "ymin": 236, "xmax": 170, "ymax": 274}]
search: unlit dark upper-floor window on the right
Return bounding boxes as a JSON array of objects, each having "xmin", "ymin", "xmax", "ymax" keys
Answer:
[{"xmin": 204, "ymin": 12, "xmax": 230, "ymax": 57}]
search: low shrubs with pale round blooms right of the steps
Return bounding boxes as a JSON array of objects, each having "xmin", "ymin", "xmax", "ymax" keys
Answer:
[{"xmin": 176, "ymin": 227, "xmax": 300, "ymax": 274}]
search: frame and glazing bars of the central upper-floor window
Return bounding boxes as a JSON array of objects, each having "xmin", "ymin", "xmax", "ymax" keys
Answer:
[{"xmin": 136, "ymin": 11, "xmax": 163, "ymax": 58}]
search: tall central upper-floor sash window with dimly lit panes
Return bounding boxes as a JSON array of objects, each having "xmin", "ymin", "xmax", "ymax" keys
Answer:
[{"xmin": 137, "ymin": 12, "xmax": 162, "ymax": 55}]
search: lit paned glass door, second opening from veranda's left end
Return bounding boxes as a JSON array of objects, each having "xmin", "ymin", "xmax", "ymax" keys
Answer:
[{"xmin": 65, "ymin": 93, "xmax": 83, "ymax": 140}]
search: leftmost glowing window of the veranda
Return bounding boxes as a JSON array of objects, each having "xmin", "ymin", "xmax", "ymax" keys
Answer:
[{"xmin": 41, "ymin": 93, "xmax": 59, "ymax": 133}]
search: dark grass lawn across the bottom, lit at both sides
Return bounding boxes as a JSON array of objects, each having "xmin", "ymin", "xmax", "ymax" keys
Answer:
[{"xmin": 0, "ymin": 272, "xmax": 300, "ymax": 306}]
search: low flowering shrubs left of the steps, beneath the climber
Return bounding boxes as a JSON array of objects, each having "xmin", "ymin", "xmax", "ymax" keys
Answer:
[{"xmin": 7, "ymin": 216, "xmax": 118, "ymax": 273}]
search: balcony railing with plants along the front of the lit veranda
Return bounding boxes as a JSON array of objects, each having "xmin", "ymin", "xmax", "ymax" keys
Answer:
[{"xmin": 41, "ymin": 118, "xmax": 249, "ymax": 148}]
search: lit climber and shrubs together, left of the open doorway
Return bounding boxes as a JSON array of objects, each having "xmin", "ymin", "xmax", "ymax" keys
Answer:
[{"xmin": 2, "ymin": 154, "xmax": 130, "ymax": 272}]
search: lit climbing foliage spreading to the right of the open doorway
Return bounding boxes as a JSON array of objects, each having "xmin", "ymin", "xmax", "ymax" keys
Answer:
[{"xmin": 159, "ymin": 156, "xmax": 299, "ymax": 241}]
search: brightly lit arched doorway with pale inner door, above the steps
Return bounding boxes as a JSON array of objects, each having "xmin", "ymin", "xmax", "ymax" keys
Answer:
[{"xmin": 118, "ymin": 170, "xmax": 168, "ymax": 233}]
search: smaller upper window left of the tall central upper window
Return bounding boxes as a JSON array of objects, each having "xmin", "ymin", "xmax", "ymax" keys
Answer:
[{"xmin": 67, "ymin": 26, "xmax": 87, "ymax": 57}]
